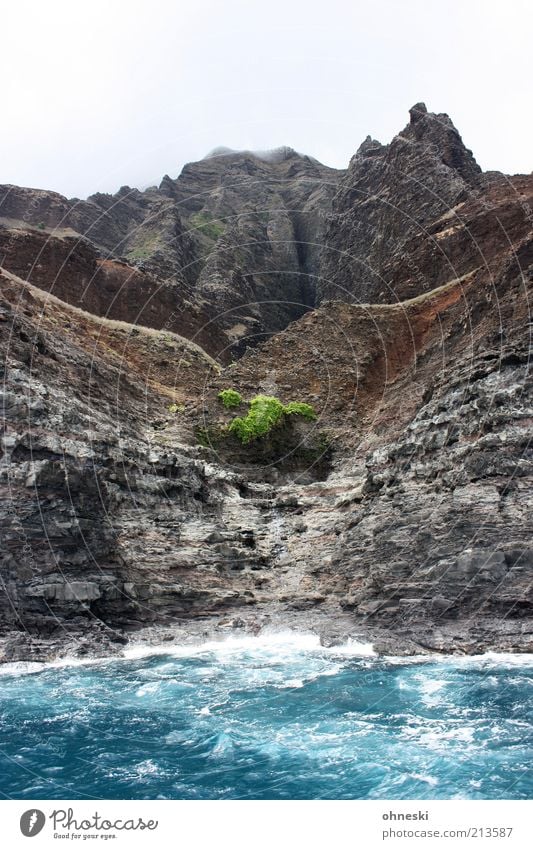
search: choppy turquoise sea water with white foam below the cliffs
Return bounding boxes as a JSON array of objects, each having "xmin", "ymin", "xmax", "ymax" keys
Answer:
[{"xmin": 0, "ymin": 634, "xmax": 533, "ymax": 799}]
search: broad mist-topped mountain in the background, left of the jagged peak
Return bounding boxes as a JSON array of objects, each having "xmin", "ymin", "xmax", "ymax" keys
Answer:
[{"xmin": 0, "ymin": 148, "xmax": 342, "ymax": 360}]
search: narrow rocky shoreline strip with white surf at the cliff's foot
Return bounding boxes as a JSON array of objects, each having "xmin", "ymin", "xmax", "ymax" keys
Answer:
[{"xmin": 4, "ymin": 608, "xmax": 533, "ymax": 665}]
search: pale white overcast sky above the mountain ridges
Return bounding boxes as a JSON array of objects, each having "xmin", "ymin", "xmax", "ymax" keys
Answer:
[{"xmin": 0, "ymin": 0, "xmax": 533, "ymax": 197}]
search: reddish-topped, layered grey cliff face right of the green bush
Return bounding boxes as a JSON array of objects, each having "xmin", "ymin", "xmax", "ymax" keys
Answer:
[{"xmin": 196, "ymin": 195, "xmax": 533, "ymax": 649}]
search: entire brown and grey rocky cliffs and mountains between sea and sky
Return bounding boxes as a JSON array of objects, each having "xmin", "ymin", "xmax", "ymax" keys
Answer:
[{"xmin": 0, "ymin": 104, "xmax": 533, "ymax": 658}]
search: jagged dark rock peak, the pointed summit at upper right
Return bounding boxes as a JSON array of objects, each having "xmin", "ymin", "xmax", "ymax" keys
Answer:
[{"xmin": 320, "ymin": 103, "xmax": 484, "ymax": 303}]
